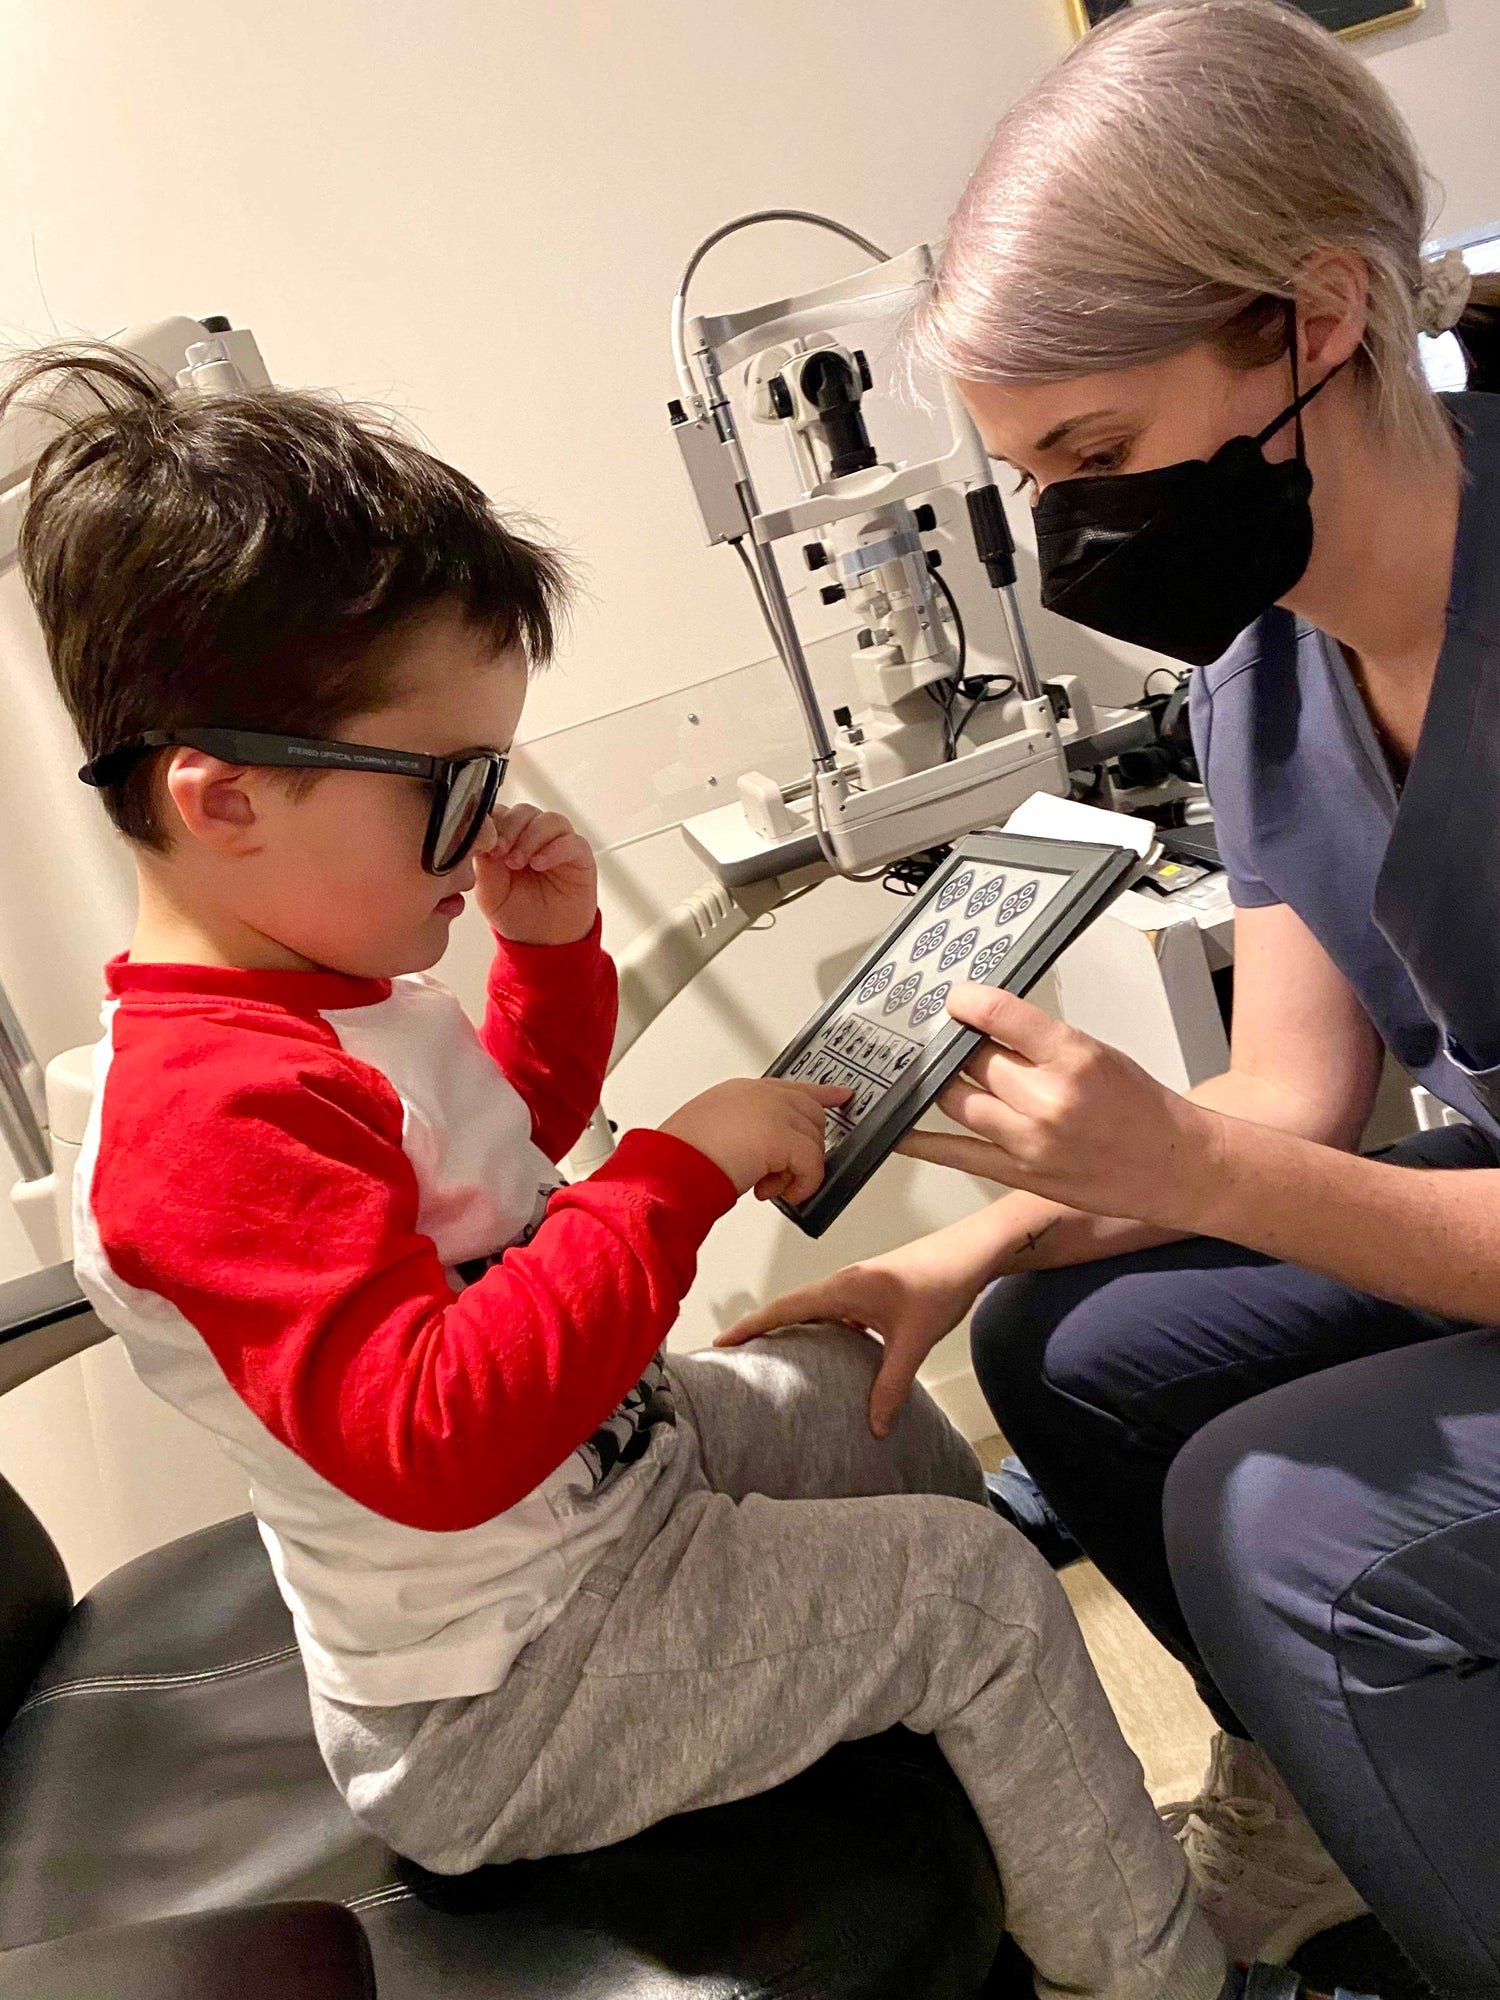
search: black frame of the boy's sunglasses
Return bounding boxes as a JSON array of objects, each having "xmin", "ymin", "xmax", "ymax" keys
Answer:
[{"xmin": 78, "ymin": 728, "xmax": 510, "ymax": 876}]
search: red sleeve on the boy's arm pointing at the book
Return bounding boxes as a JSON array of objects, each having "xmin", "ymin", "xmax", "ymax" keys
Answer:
[{"xmin": 92, "ymin": 1000, "xmax": 734, "ymax": 1530}]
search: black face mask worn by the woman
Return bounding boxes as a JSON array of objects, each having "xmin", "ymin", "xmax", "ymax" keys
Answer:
[{"xmin": 1036, "ymin": 324, "xmax": 1344, "ymax": 666}]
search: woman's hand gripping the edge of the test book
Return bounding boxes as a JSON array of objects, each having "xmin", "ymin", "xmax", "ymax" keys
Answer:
[{"xmin": 898, "ymin": 984, "xmax": 1222, "ymax": 1228}]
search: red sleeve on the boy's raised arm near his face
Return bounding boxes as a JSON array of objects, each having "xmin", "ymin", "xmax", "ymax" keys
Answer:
[{"xmin": 480, "ymin": 916, "xmax": 618, "ymax": 1160}]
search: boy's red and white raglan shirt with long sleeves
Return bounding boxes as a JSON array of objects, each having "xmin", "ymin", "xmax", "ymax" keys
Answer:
[{"xmin": 74, "ymin": 924, "xmax": 734, "ymax": 1706}]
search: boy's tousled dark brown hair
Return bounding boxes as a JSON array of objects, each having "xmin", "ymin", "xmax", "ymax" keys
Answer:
[{"xmin": 0, "ymin": 346, "xmax": 568, "ymax": 850}]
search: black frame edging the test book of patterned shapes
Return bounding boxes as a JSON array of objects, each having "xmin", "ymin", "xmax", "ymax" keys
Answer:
[{"xmin": 766, "ymin": 834, "xmax": 1140, "ymax": 1236}]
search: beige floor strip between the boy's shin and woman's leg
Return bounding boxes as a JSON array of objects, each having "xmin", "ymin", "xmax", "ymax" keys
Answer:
[{"xmin": 974, "ymin": 1438, "xmax": 1214, "ymax": 1806}]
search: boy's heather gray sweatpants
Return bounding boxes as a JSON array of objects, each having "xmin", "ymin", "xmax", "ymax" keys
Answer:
[{"xmin": 314, "ymin": 1326, "xmax": 1224, "ymax": 2000}]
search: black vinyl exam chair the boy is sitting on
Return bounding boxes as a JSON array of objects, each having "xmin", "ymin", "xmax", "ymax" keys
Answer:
[{"xmin": 0, "ymin": 1264, "xmax": 1030, "ymax": 2000}]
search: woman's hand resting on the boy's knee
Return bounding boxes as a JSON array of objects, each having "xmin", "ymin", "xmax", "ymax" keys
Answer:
[{"xmin": 714, "ymin": 1232, "xmax": 982, "ymax": 1438}]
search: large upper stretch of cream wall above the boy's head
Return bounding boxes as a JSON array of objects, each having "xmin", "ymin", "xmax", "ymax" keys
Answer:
[{"xmin": 0, "ymin": 0, "xmax": 1068, "ymax": 744}]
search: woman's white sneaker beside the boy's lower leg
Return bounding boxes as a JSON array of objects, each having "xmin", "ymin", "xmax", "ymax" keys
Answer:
[{"xmin": 1162, "ymin": 1730, "xmax": 1366, "ymax": 1966}]
